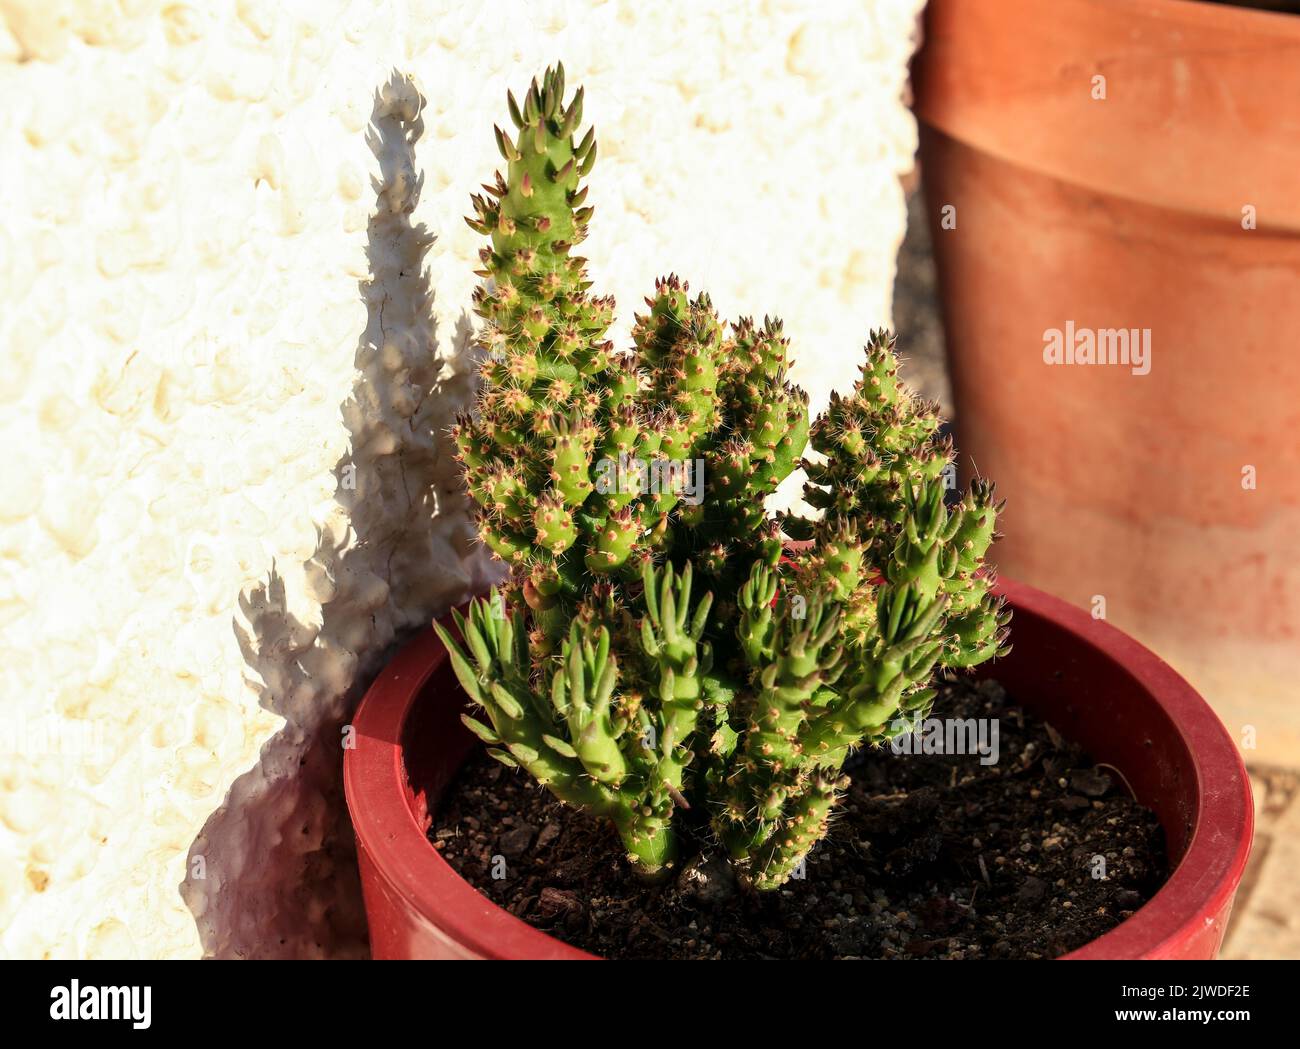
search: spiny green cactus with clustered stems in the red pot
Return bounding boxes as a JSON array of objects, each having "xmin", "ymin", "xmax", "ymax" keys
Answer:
[{"xmin": 438, "ymin": 66, "xmax": 1009, "ymax": 889}]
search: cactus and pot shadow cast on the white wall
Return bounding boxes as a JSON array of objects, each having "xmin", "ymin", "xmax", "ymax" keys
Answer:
[{"xmin": 181, "ymin": 73, "xmax": 489, "ymax": 958}]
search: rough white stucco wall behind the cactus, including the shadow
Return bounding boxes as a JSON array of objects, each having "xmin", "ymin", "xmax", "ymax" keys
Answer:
[{"xmin": 0, "ymin": 0, "xmax": 920, "ymax": 957}]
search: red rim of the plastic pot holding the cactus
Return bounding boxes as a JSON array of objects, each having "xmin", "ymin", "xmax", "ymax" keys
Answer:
[{"xmin": 343, "ymin": 580, "xmax": 1255, "ymax": 959}]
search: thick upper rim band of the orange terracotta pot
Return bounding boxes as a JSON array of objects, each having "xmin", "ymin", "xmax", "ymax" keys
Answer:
[{"xmin": 913, "ymin": 0, "xmax": 1300, "ymax": 233}]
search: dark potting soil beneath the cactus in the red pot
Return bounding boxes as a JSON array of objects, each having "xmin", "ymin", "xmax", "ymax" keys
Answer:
[{"xmin": 429, "ymin": 680, "xmax": 1167, "ymax": 959}]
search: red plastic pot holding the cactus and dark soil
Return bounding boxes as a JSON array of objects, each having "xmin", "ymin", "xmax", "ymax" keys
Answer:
[{"xmin": 343, "ymin": 580, "xmax": 1255, "ymax": 958}]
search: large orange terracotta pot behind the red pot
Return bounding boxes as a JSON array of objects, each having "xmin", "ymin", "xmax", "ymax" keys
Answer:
[{"xmin": 914, "ymin": 0, "xmax": 1300, "ymax": 763}]
